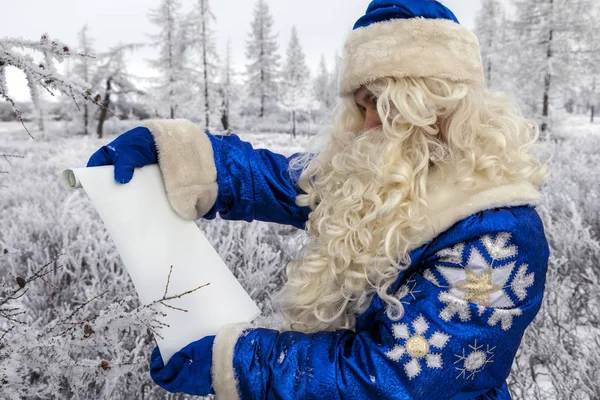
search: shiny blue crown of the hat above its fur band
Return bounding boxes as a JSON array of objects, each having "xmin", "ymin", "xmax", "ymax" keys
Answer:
[{"xmin": 353, "ymin": 0, "xmax": 458, "ymax": 29}]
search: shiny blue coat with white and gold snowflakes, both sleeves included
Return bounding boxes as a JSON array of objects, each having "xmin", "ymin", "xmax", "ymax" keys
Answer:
[{"xmin": 204, "ymin": 134, "xmax": 549, "ymax": 400}]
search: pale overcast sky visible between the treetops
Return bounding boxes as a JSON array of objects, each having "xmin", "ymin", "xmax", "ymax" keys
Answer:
[{"xmin": 0, "ymin": 0, "xmax": 480, "ymax": 101}]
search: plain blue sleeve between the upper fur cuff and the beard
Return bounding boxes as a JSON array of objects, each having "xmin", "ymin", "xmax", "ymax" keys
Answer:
[{"xmin": 203, "ymin": 132, "xmax": 310, "ymax": 229}]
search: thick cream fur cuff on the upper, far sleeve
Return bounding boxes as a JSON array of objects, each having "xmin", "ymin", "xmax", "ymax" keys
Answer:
[{"xmin": 142, "ymin": 119, "xmax": 218, "ymax": 220}]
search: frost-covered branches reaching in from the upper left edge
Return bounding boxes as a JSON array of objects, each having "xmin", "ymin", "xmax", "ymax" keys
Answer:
[{"xmin": 0, "ymin": 34, "xmax": 100, "ymax": 135}]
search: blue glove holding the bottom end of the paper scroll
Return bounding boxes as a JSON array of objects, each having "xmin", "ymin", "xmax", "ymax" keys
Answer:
[{"xmin": 150, "ymin": 336, "xmax": 215, "ymax": 396}]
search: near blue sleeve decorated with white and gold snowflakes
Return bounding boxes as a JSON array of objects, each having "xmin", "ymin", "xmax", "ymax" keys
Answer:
[{"xmin": 234, "ymin": 209, "xmax": 549, "ymax": 400}]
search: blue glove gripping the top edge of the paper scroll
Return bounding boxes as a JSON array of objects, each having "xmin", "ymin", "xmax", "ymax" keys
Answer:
[{"xmin": 87, "ymin": 126, "xmax": 158, "ymax": 183}]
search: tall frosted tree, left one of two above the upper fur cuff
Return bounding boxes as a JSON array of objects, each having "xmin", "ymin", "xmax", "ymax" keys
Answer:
[{"xmin": 148, "ymin": 0, "xmax": 192, "ymax": 118}]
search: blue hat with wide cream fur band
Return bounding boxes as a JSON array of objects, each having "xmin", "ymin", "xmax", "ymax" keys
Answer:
[{"xmin": 339, "ymin": 0, "xmax": 485, "ymax": 96}]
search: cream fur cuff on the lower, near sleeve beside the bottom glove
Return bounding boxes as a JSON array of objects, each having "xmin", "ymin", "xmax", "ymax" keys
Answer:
[{"xmin": 211, "ymin": 323, "xmax": 252, "ymax": 400}]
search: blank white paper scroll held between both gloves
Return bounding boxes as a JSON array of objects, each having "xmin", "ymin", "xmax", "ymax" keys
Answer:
[{"xmin": 62, "ymin": 165, "xmax": 260, "ymax": 363}]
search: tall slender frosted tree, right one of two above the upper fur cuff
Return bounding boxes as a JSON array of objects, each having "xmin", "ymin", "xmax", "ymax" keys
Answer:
[{"xmin": 188, "ymin": 0, "xmax": 219, "ymax": 129}]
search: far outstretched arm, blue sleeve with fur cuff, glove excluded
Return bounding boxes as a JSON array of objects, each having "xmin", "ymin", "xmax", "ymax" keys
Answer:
[{"xmin": 139, "ymin": 120, "xmax": 310, "ymax": 229}]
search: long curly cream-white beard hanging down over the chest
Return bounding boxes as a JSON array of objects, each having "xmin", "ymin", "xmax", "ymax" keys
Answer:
[{"xmin": 278, "ymin": 129, "xmax": 424, "ymax": 332}]
